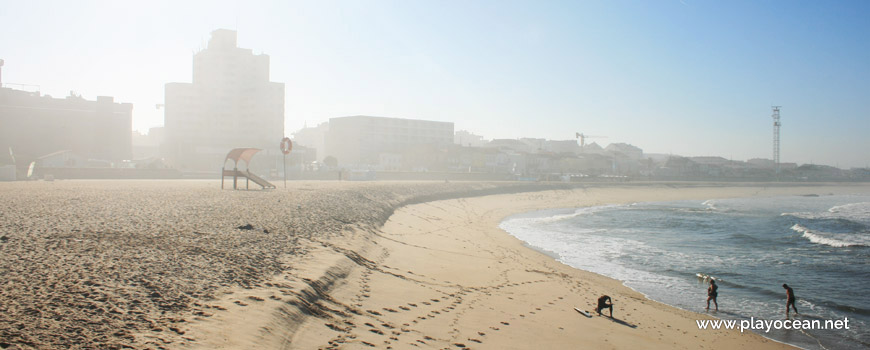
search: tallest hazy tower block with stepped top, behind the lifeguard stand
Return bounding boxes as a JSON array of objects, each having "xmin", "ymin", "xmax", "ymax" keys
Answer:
[{"xmin": 164, "ymin": 29, "xmax": 284, "ymax": 172}]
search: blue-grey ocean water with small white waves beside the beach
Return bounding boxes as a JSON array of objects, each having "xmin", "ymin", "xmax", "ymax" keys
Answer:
[{"xmin": 501, "ymin": 195, "xmax": 870, "ymax": 349}]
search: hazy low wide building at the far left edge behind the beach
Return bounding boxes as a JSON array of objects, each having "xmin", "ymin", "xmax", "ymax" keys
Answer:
[{"xmin": 0, "ymin": 88, "xmax": 133, "ymax": 174}]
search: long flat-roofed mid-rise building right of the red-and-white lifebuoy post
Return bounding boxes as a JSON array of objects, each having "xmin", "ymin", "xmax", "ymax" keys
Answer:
[{"xmin": 326, "ymin": 116, "xmax": 453, "ymax": 167}]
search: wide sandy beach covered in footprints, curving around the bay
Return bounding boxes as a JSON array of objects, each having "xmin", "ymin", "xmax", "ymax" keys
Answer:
[{"xmin": 0, "ymin": 181, "xmax": 868, "ymax": 349}]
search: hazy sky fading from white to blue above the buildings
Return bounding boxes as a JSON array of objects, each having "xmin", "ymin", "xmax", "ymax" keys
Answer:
[{"xmin": 0, "ymin": 0, "xmax": 870, "ymax": 167}]
